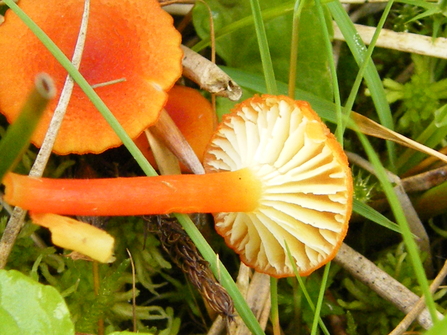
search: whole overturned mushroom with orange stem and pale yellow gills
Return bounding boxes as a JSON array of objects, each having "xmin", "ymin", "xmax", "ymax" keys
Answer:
[{"xmin": 5, "ymin": 95, "xmax": 352, "ymax": 277}]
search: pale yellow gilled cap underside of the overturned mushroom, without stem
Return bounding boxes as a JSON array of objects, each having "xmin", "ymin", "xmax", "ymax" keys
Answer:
[{"xmin": 205, "ymin": 95, "xmax": 353, "ymax": 278}]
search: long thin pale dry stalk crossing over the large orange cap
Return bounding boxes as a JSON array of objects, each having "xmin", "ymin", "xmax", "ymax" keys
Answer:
[{"xmin": 0, "ymin": 0, "xmax": 90, "ymax": 269}]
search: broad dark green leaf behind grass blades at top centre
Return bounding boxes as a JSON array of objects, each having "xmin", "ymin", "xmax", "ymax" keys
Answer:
[{"xmin": 193, "ymin": 0, "xmax": 332, "ymax": 100}]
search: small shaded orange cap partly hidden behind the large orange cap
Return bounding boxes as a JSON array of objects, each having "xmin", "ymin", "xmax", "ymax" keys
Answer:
[{"xmin": 135, "ymin": 85, "xmax": 214, "ymax": 170}]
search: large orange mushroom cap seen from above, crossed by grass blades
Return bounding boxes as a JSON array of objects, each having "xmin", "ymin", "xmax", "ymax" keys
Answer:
[{"xmin": 0, "ymin": 0, "xmax": 182, "ymax": 154}]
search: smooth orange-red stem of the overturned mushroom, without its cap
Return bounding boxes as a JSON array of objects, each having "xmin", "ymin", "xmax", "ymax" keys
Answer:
[{"xmin": 4, "ymin": 168, "xmax": 262, "ymax": 216}]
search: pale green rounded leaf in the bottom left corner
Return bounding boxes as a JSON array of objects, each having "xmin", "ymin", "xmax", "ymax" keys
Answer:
[{"xmin": 0, "ymin": 270, "xmax": 74, "ymax": 335}]
